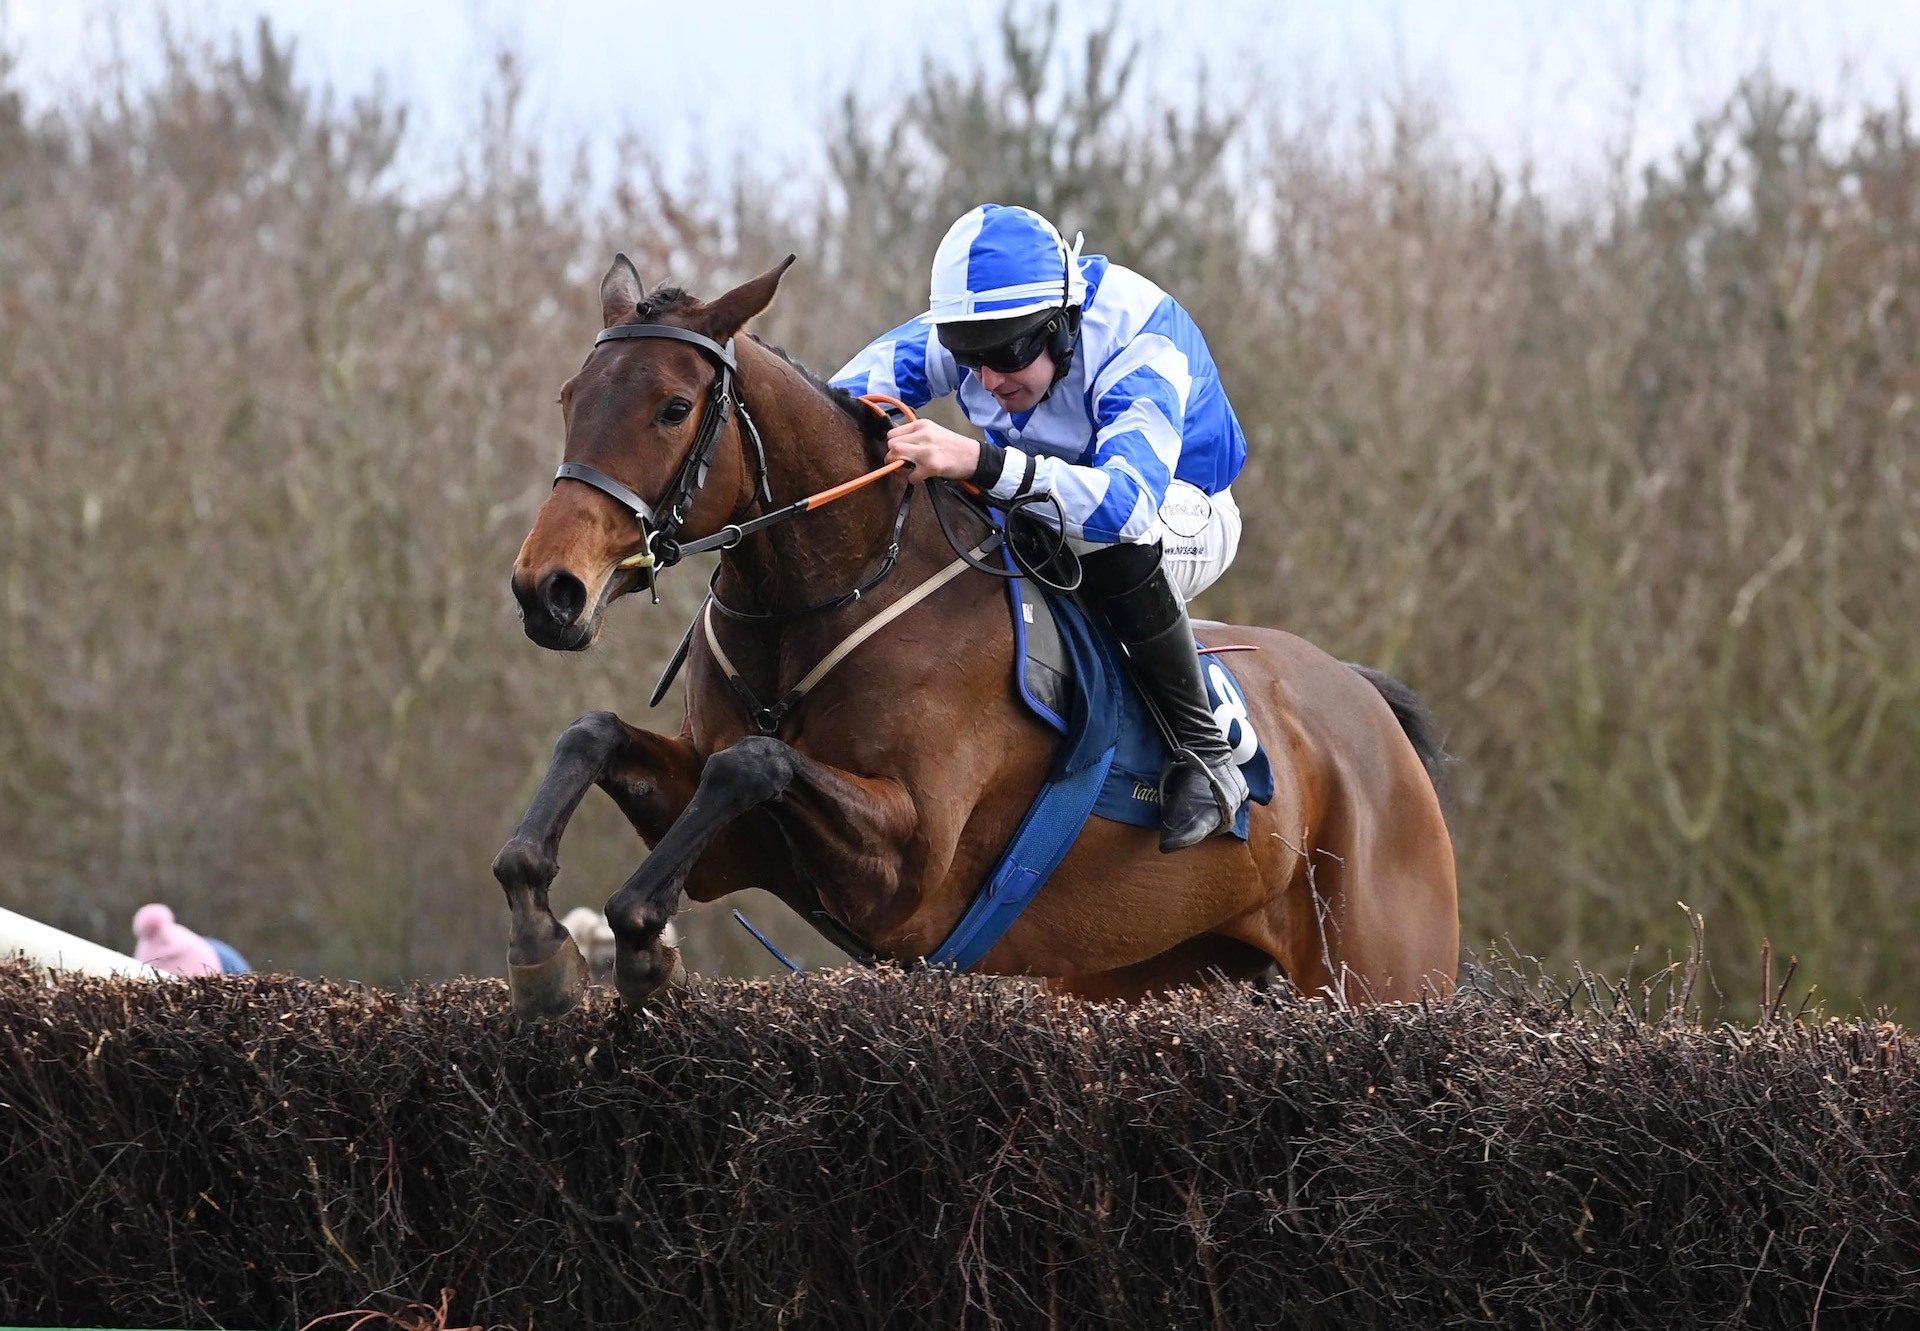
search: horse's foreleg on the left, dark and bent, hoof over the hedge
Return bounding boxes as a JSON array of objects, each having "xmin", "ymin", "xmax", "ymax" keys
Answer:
[{"xmin": 493, "ymin": 713, "xmax": 695, "ymax": 1018}]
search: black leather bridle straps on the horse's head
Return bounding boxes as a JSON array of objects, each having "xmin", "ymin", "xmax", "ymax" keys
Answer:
[{"xmin": 553, "ymin": 323, "xmax": 783, "ymax": 605}]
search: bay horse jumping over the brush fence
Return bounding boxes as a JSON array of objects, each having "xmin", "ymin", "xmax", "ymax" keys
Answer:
[{"xmin": 493, "ymin": 255, "xmax": 1459, "ymax": 1018}]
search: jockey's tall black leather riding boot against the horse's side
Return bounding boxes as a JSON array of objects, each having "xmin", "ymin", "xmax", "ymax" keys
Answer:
[{"xmin": 1081, "ymin": 542, "xmax": 1246, "ymax": 851}]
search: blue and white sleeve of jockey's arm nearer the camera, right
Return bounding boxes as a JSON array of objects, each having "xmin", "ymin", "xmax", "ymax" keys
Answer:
[{"xmin": 993, "ymin": 332, "xmax": 1192, "ymax": 545}]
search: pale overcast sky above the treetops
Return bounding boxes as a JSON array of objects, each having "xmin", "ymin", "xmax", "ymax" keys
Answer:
[{"xmin": 0, "ymin": 0, "xmax": 1920, "ymax": 195}]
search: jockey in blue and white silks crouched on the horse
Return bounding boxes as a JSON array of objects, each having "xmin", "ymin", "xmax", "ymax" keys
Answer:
[{"xmin": 833, "ymin": 204, "xmax": 1248, "ymax": 851}]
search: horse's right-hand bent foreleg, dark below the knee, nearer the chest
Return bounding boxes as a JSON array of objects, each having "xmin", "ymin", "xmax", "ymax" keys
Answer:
[{"xmin": 607, "ymin": 736, "xmax": 916, "ymax": 1003}]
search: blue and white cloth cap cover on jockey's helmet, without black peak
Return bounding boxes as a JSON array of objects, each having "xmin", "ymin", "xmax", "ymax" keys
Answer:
[{"xmin": 927, "ymin": 204, "xmax": 1087, "ymax": 323}]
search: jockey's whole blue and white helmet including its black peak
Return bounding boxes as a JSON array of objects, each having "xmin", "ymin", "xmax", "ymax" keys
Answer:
[{"xmin": 927, "ymin": 204, "xmax": 1087, "ymax": 363}]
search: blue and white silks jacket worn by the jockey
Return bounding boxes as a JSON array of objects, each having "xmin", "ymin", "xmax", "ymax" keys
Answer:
[{"xmin": 833, "ymin": 253, "xmax": 1246, "ymax": 545}]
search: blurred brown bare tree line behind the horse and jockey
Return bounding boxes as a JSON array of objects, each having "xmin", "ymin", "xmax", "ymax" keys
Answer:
[{"xmin": 0, "ymin": 21, "xmax": 1920, "ymax": 1006}]
